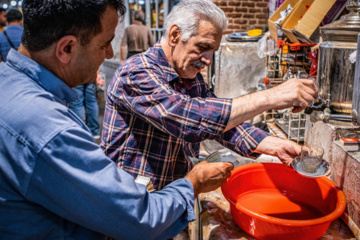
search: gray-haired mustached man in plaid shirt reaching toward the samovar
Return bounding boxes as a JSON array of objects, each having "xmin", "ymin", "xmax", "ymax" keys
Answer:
[{"xmin": 101, "ymin": 0, "xmax": 318, "ymax": 189}]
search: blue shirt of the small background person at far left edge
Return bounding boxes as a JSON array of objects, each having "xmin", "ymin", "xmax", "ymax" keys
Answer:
[{"xmin": 0, "ymin": 25, "xmax": 24, "ymax": 61}]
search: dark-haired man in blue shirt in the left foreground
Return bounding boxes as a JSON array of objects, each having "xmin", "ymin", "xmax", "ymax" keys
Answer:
[{"xmin": 0, "ymin": 0, "xmax": 233, "ymax": 240}]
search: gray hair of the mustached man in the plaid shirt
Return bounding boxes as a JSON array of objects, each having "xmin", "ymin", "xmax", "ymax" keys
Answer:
[{"xmin": 162, "ymin": 0, "xmax": 228, "ymax": 42}]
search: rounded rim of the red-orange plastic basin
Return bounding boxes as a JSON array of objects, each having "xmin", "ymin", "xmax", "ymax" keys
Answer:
[{"xmin": 221, "ymin": 163, "xmax": 346, "ymax": 226}]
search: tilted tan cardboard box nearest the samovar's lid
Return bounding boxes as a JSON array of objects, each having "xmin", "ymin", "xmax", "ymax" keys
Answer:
[{"xmin": 282, "ymin": 0, "xmax": 346, "ymax": 43}]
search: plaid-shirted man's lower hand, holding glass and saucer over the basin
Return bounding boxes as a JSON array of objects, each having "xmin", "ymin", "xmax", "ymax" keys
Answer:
[{"xmin": 255, "ymin": 136, "xmax": 301, "ymax": 166}]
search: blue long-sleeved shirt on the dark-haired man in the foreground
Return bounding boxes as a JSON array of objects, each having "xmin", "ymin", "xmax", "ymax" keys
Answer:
[{"xmin": 0, "ymin": 50, "xmax": 195, "ymax": 240}]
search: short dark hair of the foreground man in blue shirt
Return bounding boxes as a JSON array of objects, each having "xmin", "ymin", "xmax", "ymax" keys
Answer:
[{"xmin": 22, "ymin": 0, "xmax": 126, "ymax": 52}]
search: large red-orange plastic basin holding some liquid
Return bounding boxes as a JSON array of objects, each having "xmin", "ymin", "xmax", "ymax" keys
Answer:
[{"xmin": 221, "ymin": 163, "xmax": 346, "ymax": 240}]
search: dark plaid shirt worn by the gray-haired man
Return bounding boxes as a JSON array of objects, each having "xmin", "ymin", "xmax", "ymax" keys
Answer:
[{"xmin": 101, "ymin": 44, "xmax": 267, "ymax": 189}]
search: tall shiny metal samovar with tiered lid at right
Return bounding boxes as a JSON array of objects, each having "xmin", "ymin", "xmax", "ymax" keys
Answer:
[{"xmin": 318, "ymin": 0, "xmax": 360, "ymax": 114}]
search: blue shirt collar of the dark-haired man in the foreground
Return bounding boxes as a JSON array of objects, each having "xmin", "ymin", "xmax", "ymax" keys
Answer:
[{"xmin": 7, "ymin": 49, "xmax": 77, "ymax": 104}]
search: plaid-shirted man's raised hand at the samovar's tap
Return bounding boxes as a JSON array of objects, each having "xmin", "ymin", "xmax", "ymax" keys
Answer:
[{"xmin": 266, "ymin": 78, "xmax": 318, "ymax": 113}]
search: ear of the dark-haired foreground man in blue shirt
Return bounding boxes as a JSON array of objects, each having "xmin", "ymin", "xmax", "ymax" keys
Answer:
[{"xmin": 55, "ymin": 35, "xmax": 78, "ymax": 64}]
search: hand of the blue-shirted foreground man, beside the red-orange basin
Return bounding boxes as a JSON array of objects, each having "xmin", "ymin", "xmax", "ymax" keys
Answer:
[{"xmin": 185, "ymin": 161, "xmax": 234, "ymax": 197}]
